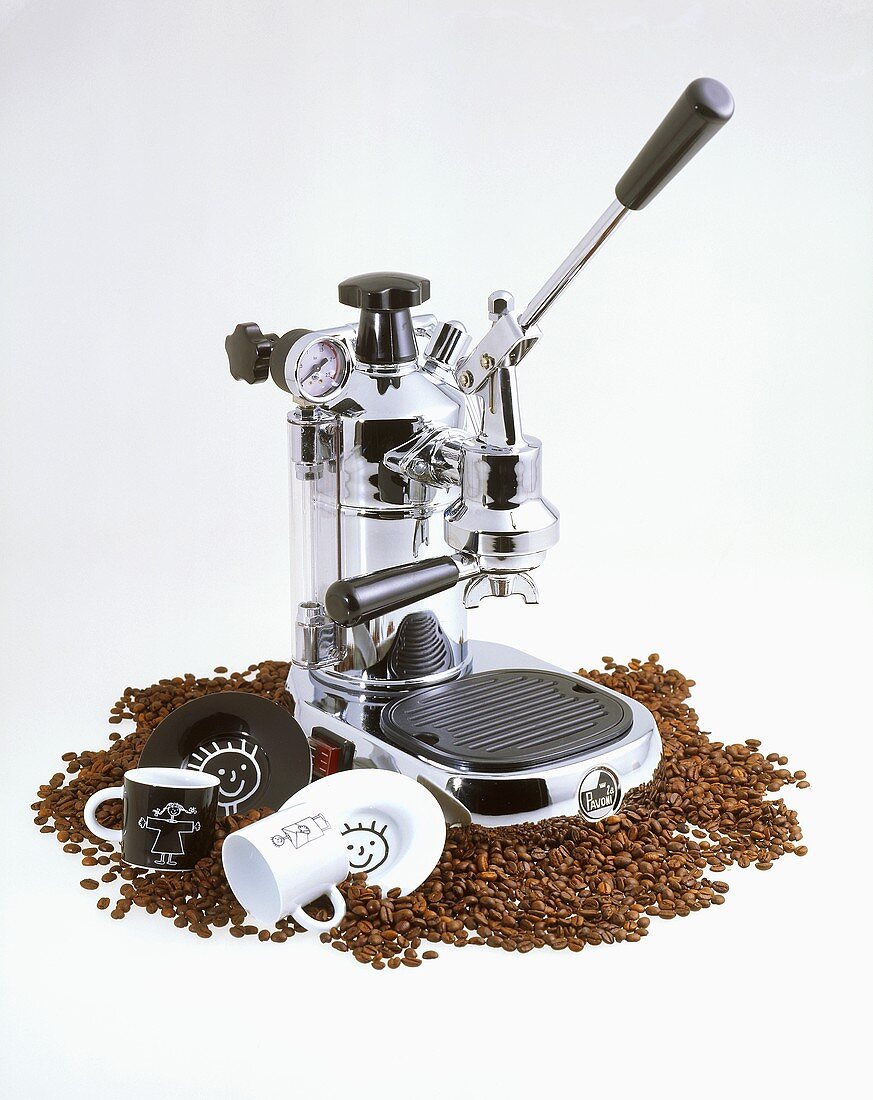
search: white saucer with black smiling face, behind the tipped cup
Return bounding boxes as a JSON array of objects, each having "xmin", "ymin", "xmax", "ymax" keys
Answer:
[{"xmin": 286, "ymin": 768, "xmax": 445, "ymax": 894}]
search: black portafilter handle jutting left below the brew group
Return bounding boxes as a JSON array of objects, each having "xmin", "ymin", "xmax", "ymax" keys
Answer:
[{"xmin": 324, "ymin": 557, "xmax": 461, "ymax": 626}]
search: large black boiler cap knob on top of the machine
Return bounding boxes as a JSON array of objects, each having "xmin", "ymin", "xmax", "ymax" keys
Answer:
[{"xmin": 340, "ymin": 272, "xmax": 430, "ymax": 366}]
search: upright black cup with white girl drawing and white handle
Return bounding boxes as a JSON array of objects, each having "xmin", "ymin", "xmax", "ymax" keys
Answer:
[{"xmin": 85, "ymin": 768, "xmax": 220, "ymax": 871}]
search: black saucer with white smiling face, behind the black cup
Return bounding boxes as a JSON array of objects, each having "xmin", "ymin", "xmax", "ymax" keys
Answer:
[{"xmin": 140, "ymin": 691, "xmax": 312, "ymax": 814}]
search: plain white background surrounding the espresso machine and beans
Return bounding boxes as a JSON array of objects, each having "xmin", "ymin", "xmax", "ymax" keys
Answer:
[{"xmin": 0, "ymin": 0, "xmax": 873, "ymax": 1098}]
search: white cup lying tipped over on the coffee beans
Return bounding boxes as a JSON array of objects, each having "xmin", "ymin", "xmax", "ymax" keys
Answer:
[{"xmin": 221, "ymin": 802, "xmax": 349, "ymax": 931}]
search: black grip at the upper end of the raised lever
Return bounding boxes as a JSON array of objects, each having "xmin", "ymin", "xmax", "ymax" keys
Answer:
[{"xmin": 616, "ymin": 77, "xmax": 733, "ymax": 210}]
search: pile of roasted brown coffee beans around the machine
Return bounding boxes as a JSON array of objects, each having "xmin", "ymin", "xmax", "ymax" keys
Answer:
[{"xmin": 33, "ymin": 653, "xmax": 809, "ymax": 970}]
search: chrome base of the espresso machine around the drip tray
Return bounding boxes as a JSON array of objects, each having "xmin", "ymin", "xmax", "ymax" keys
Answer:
[{"xmin": 288, "ymin": 641, "xmax": 661, "ymax": 826}]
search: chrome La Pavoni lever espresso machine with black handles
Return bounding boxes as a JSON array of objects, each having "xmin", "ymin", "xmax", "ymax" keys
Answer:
[{"xmin": 225, "ymin": 78, "xmax": 733, "ymax": 825}]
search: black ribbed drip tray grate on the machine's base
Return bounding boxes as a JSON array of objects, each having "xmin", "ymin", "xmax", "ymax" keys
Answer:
[{"xmin": 382, "ymin": 669, "xmax": 633, "ymax": 771}]
